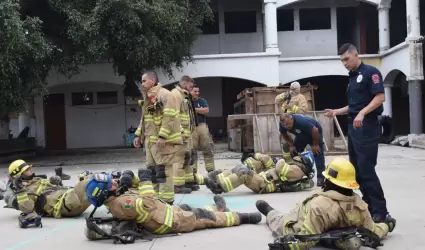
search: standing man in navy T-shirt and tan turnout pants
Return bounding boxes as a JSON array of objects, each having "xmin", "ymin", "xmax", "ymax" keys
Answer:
[{"xmin": 192, "ymin": 85, "xmax": 215, "ymax": 173}]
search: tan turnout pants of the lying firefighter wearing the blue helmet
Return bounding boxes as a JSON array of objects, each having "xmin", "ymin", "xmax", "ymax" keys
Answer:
[{"xmin": 171, "ymin": 206, "xmax": 240, "ymax": 233}]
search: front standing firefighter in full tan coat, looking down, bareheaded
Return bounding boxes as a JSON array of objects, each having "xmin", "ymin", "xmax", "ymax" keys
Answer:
[{"xmin": 133, "ymin": 71, "xmax": 186, "ymax": 204}]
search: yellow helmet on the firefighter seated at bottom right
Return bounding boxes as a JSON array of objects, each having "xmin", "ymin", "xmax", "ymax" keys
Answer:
[{"xmin": 322, "ymin": 158, "xmax": 359, "ymax": 189}]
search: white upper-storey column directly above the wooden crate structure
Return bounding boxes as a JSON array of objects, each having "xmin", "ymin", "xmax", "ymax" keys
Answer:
[{"xmin": 264, "ymin": 0, "xmax": 279, "ymax": 52}]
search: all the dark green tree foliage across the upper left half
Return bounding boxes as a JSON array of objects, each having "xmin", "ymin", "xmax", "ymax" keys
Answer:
[{"xmin": 0, "ymin": 0, "xmax": 212, "ymax": 115}]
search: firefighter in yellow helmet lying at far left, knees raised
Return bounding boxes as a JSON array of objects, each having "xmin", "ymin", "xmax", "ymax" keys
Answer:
[{"xmin": 9, "ymin": 160, "xmax": 90, "ymax": 228}]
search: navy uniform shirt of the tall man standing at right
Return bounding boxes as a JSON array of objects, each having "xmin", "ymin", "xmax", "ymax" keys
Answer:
[{"xmin": 347, "ymin": 63, "xmax": 385, "ymax": 116}]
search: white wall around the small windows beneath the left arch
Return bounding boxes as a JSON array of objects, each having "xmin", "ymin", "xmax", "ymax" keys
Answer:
[{"xmin": 40, "ymin": 83, "xmax": 126, "ymax": 149}]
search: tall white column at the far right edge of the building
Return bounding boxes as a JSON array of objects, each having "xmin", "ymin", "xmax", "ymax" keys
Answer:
[{"xmin": 406, "ymin": 0, "xmax": 424, "ymax": 134}]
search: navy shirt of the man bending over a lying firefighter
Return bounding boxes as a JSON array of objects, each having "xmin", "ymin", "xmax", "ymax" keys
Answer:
[{"xmin": 279, "ymin": 114, "xmax": 323, "ymax": 143}]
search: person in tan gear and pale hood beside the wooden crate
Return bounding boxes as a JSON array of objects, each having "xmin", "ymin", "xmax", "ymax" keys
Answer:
[{"xmin": 275, "ymin": 82, "xmax": 309, "ymax": 114}]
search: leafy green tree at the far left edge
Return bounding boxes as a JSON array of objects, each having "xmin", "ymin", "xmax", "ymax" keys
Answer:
[{"xmin": 0, "ymin": 0, "xmax": 53, "ymax": 135}]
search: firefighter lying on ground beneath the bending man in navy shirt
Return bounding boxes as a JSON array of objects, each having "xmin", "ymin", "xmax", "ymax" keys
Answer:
[{"xmin": 207, "ymin": 148, "xmax": 314, "ymax": 194}]
